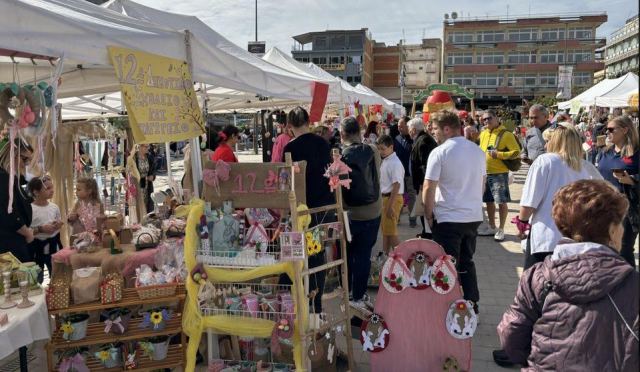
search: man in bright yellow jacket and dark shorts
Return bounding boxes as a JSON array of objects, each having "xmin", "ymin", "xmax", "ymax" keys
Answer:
[{"xmin": 478, "ymin": 110, "xmax": 521, "ymax": 242}]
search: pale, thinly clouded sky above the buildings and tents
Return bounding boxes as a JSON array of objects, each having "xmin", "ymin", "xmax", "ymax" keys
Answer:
[{"xmin": 133, "ymin": 0, "xmax": 638, "ymax": 54}]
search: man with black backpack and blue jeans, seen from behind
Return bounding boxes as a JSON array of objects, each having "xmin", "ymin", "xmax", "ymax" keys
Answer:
[{"xmin": 340, "ymin": 116, "xmax": 382, "ymax": 308}]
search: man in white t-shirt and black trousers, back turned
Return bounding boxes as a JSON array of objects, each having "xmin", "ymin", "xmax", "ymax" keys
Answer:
[{"xmin": 422, "ymin": 111, "xmax": 487, "ymax": 312}]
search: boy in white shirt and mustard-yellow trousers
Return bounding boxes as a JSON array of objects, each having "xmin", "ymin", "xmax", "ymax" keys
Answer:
[{"xmin": 376, "ymin": 134, "xmax": 404, "ymax": 255}]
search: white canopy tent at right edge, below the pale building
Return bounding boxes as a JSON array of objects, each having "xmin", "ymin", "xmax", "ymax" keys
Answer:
[{"xmin": 558, "ymin": 72, "xmax": 638, "ymax": 110}]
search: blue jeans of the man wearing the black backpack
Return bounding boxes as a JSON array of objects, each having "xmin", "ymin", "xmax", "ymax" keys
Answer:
[{"xmin": 347, "ymin": 217, "xmax": 380, "ymax": 301}]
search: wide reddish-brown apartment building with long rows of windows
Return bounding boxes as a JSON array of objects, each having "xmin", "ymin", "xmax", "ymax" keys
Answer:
[{"xmin": 442, "ymin": 13, "xmax": 607, "ymax": 106}]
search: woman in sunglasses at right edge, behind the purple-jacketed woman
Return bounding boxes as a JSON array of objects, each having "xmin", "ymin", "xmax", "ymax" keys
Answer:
[{"xmin": 596, "ymin": 116, "xmax": 640, "ymax": 267}]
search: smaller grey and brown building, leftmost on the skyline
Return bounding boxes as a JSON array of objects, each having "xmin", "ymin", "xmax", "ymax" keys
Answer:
[{"xmin": 291, "ymin": 28, "xmax": 373, "ymax": 87}]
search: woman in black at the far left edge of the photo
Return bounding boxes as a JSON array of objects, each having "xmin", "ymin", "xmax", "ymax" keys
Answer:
[{"xmin": 0, "ymin": 138, "xmax": 33, "ymax": 262}]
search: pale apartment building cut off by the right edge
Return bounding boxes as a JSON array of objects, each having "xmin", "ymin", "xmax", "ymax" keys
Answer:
[{"xmin": 604, "ymin": 14, "xmax": 640, "ymax": 78}]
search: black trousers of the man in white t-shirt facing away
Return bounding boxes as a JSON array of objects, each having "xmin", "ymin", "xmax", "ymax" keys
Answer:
[{"xmin": 432, "ymin": 221, "xmax": 481, "ymax": 303}]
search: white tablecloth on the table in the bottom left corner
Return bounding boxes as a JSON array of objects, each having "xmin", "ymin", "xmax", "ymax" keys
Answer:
[{"xmin": 0, "ymin": 292, "xmax": 51, "ymax": 359}]
